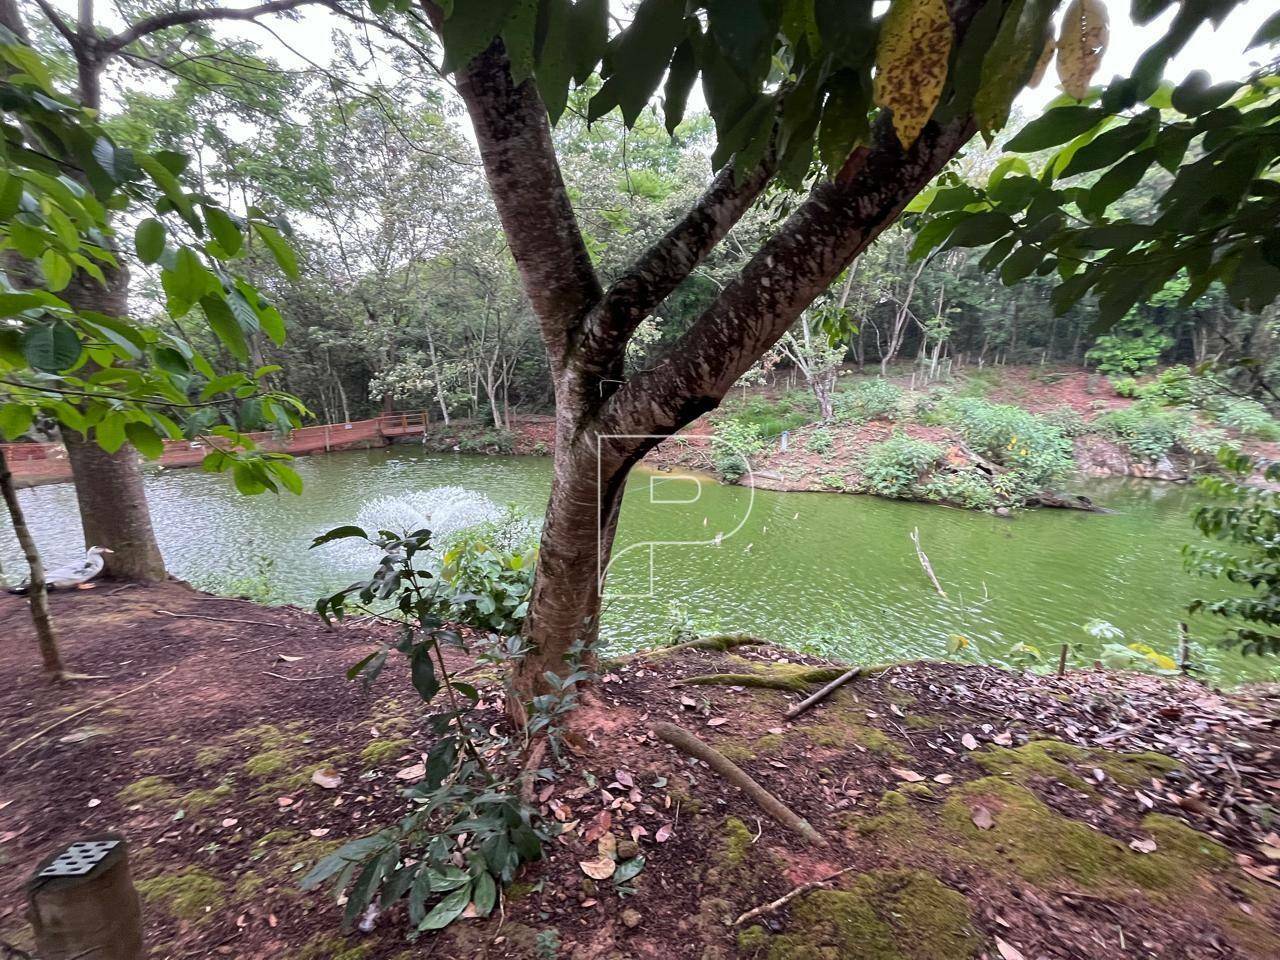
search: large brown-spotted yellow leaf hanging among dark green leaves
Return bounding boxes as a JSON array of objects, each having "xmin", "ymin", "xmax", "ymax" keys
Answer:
[{"xmin": 876, "ymin": 0, "xmax": 954, "ymax": 150}]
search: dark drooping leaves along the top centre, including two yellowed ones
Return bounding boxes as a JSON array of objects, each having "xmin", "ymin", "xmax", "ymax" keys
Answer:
[{"xmin": 399, "ymin": 0, "xmax": 1218, "ymax": 186}]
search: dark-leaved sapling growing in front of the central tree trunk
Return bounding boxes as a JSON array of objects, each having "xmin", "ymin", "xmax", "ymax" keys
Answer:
[{"xmin": 302, "ymin": 526, "xmax": 590, "ymax": 931}]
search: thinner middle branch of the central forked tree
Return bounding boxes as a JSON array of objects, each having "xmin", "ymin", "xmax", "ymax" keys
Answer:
[{"xmin": 573, "ymin": 159, "xmax": 773, "ymax": 391}]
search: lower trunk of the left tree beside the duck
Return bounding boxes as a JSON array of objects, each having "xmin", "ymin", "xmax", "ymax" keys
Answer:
[{"xmin": 63, "ymin": 430, "xmax": 165, "ymax": 584}]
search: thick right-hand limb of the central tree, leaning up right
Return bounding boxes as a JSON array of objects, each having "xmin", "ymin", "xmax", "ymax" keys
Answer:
[{"xmin": 604, "ymin": 116, "xmax": 974, "ymax": 434}]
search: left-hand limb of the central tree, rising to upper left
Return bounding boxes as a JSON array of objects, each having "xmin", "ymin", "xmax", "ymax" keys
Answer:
[{"xmin": 422, "ymin": 0, "xmax": 603, "ymax": 383}]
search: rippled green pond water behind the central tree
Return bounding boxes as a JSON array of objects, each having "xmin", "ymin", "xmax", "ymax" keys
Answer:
[{"xmin": 0, "ymin": 447, "xmax": 1277, "ymax": 682}]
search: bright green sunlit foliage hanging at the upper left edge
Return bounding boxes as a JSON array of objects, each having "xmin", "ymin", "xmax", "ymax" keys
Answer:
[{"xmin": 0, "ymin": 36, "xmax": 305, "ymax": 493}]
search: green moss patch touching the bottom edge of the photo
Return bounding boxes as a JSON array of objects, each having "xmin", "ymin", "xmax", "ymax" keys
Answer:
[{"xmin": 739, "ymin": 870, "xmax": 982, "ymax": 960}]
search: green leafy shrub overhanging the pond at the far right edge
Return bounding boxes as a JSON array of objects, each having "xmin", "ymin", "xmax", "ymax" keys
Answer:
[{"xmin": 1183, "ymin": 449, "xmax": 1280, "ymax": 655}]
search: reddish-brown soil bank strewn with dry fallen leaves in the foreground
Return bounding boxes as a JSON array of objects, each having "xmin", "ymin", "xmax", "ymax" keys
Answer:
[{"xmin": 0, "ymin": 584, "xmax": 1280, "ymax": 960}]
